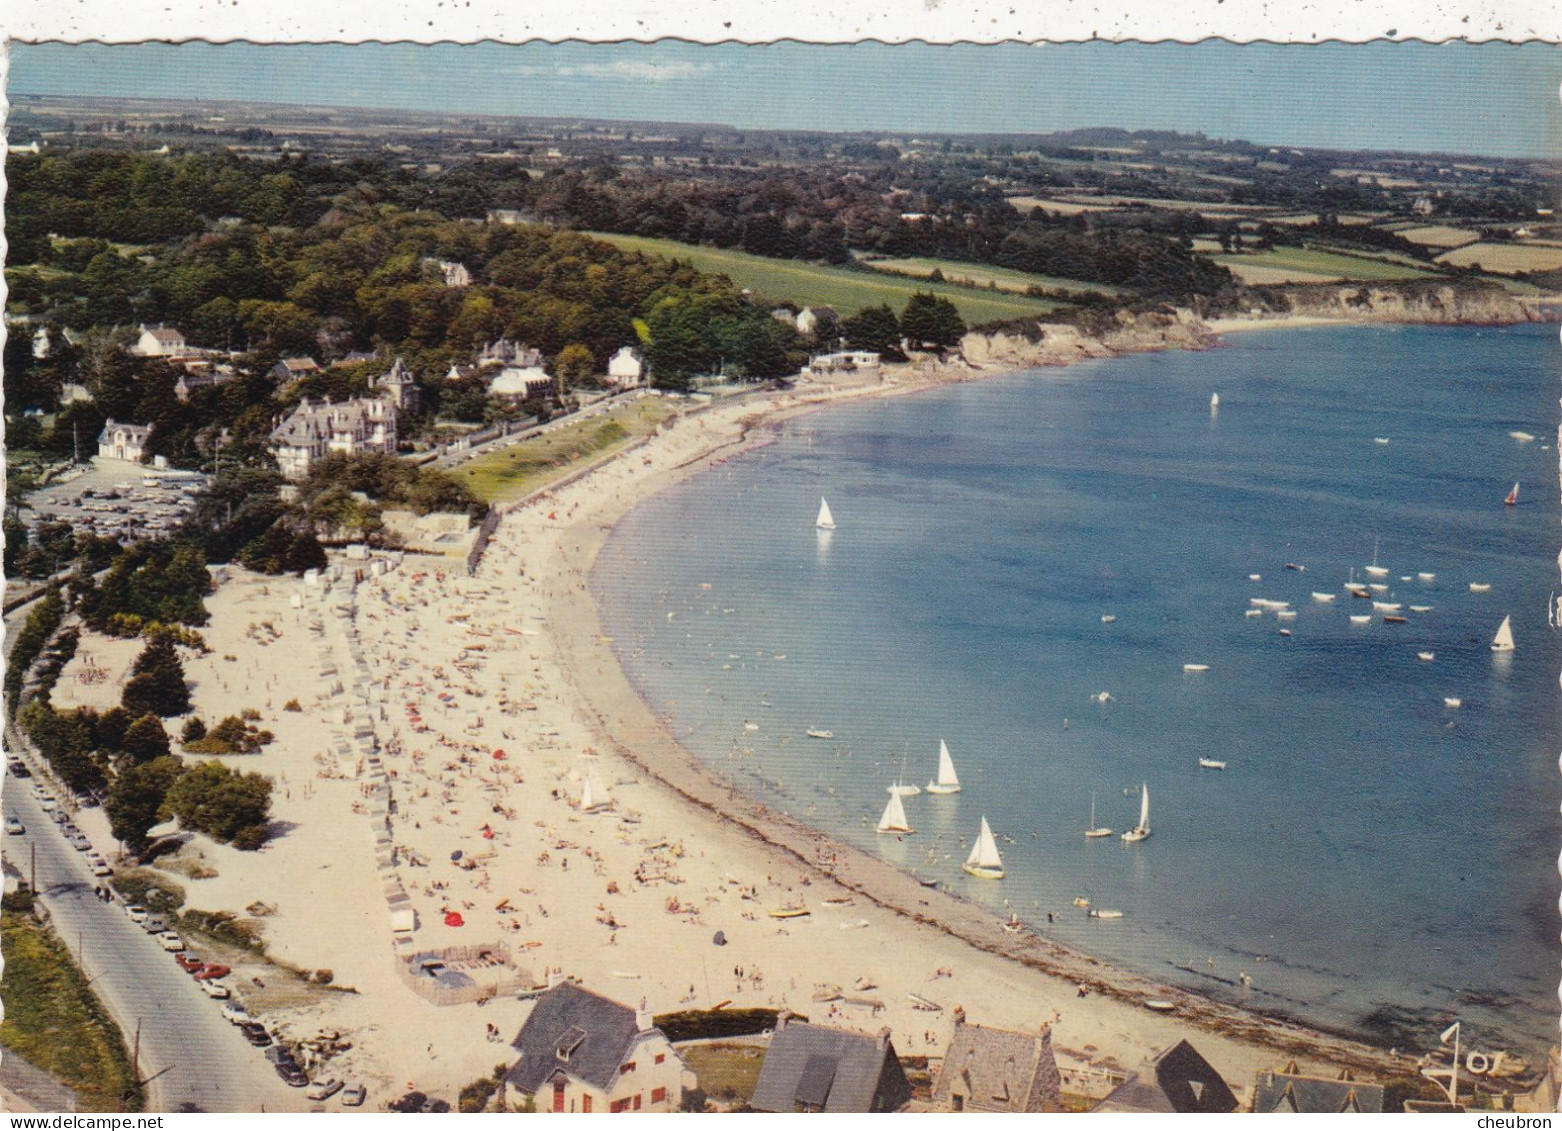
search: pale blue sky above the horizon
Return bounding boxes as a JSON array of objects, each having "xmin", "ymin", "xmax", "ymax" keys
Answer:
[{"xmin": 9, "ymin": 41, "xmax": 1562, "ymax": 158}]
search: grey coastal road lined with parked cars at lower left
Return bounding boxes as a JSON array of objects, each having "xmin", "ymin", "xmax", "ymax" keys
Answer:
[{"xmin": 3, "ymin": 773, "xmax": 308, "ymax": 1112}]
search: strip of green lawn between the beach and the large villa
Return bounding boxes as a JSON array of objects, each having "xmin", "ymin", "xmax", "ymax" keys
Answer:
[{"xmin": 450, "ymin": 397, "xmax": 681, "ymax": 503}]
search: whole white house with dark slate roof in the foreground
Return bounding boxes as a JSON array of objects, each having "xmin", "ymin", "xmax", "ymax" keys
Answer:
[{"xmin": 505, "ymin": 981, "xmax": 695, "ymax": 1112}]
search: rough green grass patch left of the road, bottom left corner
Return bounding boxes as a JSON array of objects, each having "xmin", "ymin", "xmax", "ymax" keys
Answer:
[{"xmin": 0, "ymin": 911, "xmax": 142, "ymax": 1111}]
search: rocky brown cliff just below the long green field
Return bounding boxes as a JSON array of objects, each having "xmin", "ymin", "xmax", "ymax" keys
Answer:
[{"xmin": 961, "ymin": 311, "xmax": 1220, "ymax": 369}]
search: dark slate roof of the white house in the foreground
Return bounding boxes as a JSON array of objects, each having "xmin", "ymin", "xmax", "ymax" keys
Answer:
[{"xmin": 506, "ymin": 983, "xmax": 640, "ymax": 1094}]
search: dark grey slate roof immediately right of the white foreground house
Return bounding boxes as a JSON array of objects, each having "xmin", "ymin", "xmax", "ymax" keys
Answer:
[{"xmin": 748, "ymin": 1020, "xmax": 911, "ymax": 1112}]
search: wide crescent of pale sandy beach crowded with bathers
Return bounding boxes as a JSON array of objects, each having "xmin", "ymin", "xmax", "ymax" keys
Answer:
[{"xmin": 55, "ymin": 326, "xmax": 1424, "ymax": 1108}]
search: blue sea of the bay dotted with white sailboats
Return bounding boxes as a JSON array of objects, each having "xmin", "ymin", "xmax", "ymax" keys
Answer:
[{"xmin": 594, "ymin": 326, "xmax": 1562, "ymax": 1059}]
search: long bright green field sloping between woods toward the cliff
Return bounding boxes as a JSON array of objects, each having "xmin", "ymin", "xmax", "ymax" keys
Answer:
[{"xmin": 587, "ymin": 231, "xmax": 1062, "ymax": 326}]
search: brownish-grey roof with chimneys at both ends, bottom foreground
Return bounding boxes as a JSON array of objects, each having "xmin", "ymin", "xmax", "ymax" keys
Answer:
[{"xmin": 933, "ymin": 1014, "xmax": 1062, "ymax": 1112}]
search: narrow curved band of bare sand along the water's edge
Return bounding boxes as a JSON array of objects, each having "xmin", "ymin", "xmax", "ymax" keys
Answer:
[{"xmin": 515, "ymin": 342, "xmax": 1409, "ymax": 1075}]
